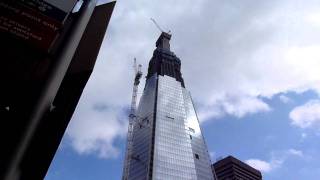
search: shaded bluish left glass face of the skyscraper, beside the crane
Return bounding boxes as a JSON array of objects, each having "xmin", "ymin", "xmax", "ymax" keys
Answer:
[{"xmin": 128, "ymin": 75, "xmax": 157, "ymax": 180}]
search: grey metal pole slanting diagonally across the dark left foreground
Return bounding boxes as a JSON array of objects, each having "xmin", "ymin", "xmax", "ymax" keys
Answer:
[{"xmin": 4, "ymin": 0, "xmax": 96, "ymax": 180}]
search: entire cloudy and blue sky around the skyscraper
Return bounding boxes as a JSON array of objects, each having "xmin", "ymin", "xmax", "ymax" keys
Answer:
[{"xmin": 46, "ymin": 0, "xmax": 320, "ymax": 180}]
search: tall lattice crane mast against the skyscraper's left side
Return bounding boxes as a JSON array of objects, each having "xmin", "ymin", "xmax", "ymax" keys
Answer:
[{"xmin": 122, "ymin": 58, "xmax": 142, "ymax": 180}]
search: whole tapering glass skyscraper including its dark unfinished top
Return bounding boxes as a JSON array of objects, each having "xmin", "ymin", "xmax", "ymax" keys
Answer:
[{"xmin": 126, "ymin": 32, "xmax": 214, "ymax": 180}]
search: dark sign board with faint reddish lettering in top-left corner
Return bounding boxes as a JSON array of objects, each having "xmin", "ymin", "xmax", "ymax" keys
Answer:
[{"xmin": 0, "ymin": 0, "xmax": 75, "ymax": 51}]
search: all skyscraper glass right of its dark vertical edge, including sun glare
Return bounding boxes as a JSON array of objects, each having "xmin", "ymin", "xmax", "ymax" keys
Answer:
[{"xmin": 152, "ymin": 75, "xmax": 213, "ymax": 180}]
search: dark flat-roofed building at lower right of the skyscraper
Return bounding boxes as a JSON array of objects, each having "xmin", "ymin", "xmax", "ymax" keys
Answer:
[{"xmin": 212, "ymin": 156, "xmax": 262, "ymax": 180}]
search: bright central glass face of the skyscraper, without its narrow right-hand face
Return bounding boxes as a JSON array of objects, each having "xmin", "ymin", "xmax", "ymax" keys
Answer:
[{"xmin": 153, "ymin": 76, "xmax": 197, "ymax": 180}]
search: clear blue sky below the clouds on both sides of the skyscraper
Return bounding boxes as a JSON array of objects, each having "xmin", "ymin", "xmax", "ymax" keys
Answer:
[{"xmin": 46, "ymin": 91, "xmax": 320, "ymax": 180}]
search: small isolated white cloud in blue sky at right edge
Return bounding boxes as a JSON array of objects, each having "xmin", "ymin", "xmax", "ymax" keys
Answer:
[{"xmin": 289, "ymin": 100, "xmax": 320, "ymax": 128}]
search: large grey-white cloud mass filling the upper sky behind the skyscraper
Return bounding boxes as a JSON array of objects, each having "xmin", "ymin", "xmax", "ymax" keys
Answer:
[{"xmin": 67, "ymin": 0, "xmax": 320, "ymax": 158}]
